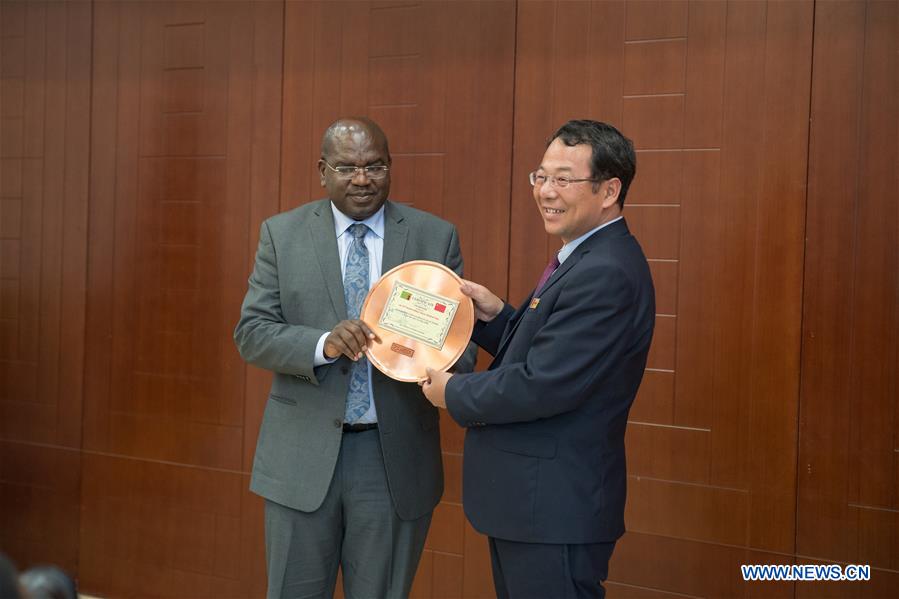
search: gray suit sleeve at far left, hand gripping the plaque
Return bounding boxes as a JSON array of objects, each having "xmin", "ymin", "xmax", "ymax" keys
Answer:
[{"xmin": 234, "ymin": 223, "xmax": 327, "ymax": 385}]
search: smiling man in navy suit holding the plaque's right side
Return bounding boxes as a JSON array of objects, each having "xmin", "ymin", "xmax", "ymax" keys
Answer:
[{"xmin": 424, "ymin": 120, "xmax": 655, "ymax": 599}]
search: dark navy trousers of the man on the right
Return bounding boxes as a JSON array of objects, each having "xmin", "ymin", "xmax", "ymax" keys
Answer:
[{"xmin": 489, "ymin": 537, "xmax": 615, "ymax": 599}]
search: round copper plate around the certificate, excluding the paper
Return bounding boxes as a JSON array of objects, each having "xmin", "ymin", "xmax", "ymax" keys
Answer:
[{"xmin": 360, "ymin": 260, "xmax": 474, "ymax": 382}]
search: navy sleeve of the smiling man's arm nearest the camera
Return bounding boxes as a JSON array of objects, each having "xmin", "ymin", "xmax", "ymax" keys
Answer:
[{"xmin": 446, "ymin": 265, "xmax": 635, "ymax": 426}]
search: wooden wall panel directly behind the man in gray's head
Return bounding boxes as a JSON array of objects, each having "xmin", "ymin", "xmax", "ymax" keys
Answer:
[{"xmin": 282, "ymin": 1, "xmax": 515, "ymax": 597}]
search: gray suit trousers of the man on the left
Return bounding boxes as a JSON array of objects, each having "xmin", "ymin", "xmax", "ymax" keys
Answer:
[{"xmin": 265, "ymin": 430, "xmax": 431, "ymax": 599}]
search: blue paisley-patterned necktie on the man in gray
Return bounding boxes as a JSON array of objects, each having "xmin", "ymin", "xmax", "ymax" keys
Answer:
[{"xmin": 343, "ymin": 223, "xmax": 369, "ymax": 423}]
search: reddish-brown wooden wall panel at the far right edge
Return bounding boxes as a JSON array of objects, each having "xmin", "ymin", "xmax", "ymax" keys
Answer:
[{"xmin": 797, "ymin": 1, "xmax": 899, "ymax": 597}]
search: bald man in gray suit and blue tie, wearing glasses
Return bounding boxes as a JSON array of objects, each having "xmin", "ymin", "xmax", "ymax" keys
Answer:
[{"xmin": 234, "ymin": 118, "xmax": 475, "ymax": 599}]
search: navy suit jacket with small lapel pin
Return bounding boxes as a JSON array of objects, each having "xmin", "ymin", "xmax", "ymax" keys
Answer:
[{"xmin": 446, "ymin": 219, "xmax": 655, "ymax": 544}]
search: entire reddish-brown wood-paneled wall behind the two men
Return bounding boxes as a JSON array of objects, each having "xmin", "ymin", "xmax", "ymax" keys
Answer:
[{"xmin": 0, "ymin": 0, "xmax": 899, "ymax": 598}]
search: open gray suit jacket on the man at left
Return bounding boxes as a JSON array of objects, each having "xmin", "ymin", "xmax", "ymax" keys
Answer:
[{"xmin": 234, "ymin": 200, "xmax": 476, "ymax": 519}]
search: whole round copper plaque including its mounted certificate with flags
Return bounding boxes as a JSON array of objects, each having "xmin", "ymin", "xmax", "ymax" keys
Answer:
[{"xmin": 360, "ymin": 260, "xmax": 474, "ymax": 382}]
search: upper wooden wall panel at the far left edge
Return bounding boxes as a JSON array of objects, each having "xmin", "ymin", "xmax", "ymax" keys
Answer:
[{"xmin": 0, "ymin": 2, "xmax": 91, "ymax": 447}]
